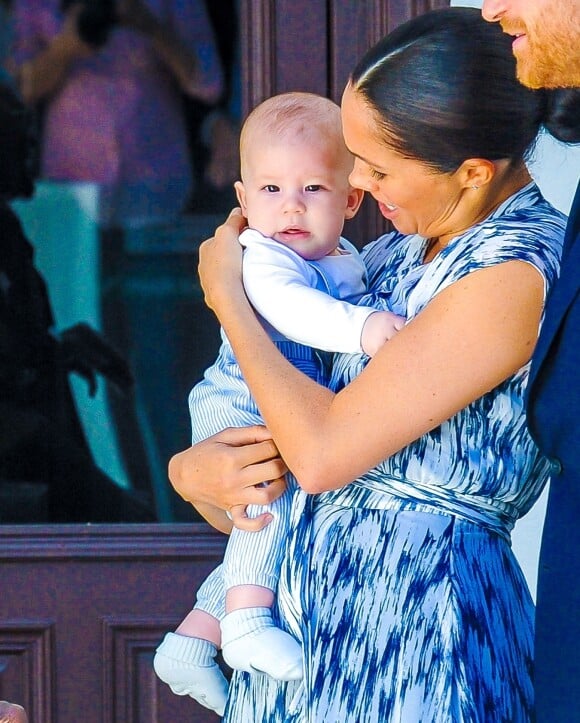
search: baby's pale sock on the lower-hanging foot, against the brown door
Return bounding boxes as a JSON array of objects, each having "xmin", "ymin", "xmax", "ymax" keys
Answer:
[{"xmin": 153, "ymin": 633, "xmax": 228, "ymax": 716}]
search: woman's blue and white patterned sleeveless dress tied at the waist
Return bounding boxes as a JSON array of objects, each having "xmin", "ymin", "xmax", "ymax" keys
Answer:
[{"xmin": 225, "ymin": 184, "xmax": 565, "ymax": 723}]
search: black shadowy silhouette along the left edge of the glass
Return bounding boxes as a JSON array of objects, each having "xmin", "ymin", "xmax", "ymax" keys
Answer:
[{"xmin": 0, "ymin": 79, "xmax": 155, "ymax": 523}]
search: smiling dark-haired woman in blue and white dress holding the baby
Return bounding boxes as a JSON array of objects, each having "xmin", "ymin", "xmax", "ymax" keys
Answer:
[{"xmin": 171, "ymin": 8, "xmax": 565, "ymax": 723}]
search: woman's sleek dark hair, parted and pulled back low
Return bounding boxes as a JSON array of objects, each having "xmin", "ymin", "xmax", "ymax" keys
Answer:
[{"xmin": 350, "ymin": 7, "xmax": 576, "ymax": 173}]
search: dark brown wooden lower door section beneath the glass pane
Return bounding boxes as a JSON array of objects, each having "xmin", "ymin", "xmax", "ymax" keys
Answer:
[{"xmin": 0, "ymin": 523, "xmax": 225, "ymax": 723}]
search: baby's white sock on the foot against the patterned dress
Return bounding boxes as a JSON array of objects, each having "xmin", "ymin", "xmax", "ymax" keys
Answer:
[{"xmin": 220, "ymin": 608, "xmax": 302, "ymax": 680}]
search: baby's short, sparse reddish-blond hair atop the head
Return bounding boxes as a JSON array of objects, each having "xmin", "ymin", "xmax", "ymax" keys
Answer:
[{"xmin": 240, "ymin": 91, "xmax": 352, "ymax": 178}]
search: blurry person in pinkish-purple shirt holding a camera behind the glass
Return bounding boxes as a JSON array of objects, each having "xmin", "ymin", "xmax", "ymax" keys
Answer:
[{"xmin": 8, "ymin": 0, "xmax": 224, "ymax": 226}]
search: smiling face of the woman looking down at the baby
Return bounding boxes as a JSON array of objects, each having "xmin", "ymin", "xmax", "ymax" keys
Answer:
[{"xmin": 341, "ymin": 85, "xmax": 465, "ymax": 243}]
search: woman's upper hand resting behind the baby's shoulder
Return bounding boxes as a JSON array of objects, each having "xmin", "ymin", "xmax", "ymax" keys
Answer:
[{"xmin": 198, "ymin": 208, "xmax": 247, "ymax": 316}]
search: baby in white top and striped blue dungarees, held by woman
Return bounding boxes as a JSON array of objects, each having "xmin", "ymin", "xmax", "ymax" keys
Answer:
[{"xmin": 154, "ymin": 93, "xmax": 404, "ymax": 715}]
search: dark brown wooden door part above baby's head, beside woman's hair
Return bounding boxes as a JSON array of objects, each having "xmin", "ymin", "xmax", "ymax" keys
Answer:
[{"xmin": 240, "ymin": 0, "xmax": 449, "ymax": 114}]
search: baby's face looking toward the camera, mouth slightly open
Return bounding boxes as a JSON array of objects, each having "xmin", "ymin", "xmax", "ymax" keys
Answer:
[{"xmin": 236, "ymin": 138, "xmax": 358, "ymax": 259}]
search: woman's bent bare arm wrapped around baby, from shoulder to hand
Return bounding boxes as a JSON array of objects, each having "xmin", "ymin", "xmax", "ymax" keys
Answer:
[{"xmin": 200, "ymin": 215, "xmax": 543, "ymax": 493}]
